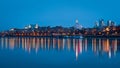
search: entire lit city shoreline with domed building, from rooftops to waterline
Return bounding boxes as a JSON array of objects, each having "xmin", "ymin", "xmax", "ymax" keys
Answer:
[{"xmin": 0, "ymin": 19, "xmax": 120, "ymax": 38}]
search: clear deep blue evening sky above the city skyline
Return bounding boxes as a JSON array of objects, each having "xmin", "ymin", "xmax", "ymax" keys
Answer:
[{"xmin": 0, "ymin": 0, "xmax": 120, "ymax": 30}]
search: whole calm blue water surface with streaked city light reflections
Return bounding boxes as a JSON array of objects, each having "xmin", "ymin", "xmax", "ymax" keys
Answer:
[{"xmin": 0, "ymin": 37, "xmax": 120, "ymax": 68}]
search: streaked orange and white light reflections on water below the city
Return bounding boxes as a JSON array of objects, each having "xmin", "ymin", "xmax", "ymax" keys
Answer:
[{"xmin": 0, "ymin": 37, "xmax": 120, "ymax": 59}]
